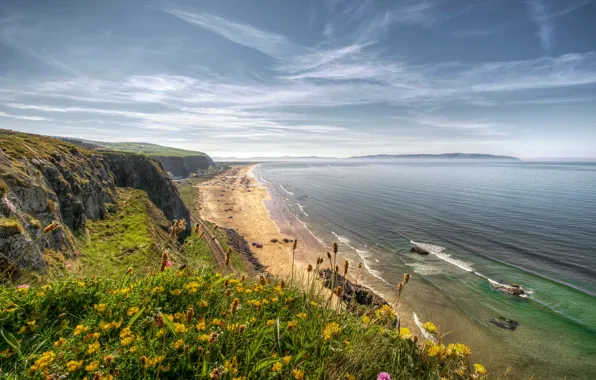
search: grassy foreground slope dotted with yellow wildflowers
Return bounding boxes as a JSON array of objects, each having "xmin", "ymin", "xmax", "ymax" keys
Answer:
[{"xmin": 0, "ymin": 268, "xmax": 484, "ymax": 379}]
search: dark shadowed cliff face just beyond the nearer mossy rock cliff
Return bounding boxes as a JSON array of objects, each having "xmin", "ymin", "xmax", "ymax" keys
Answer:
[{"xmin": 103, "ymin": 152, "xmax": 191, "ymax": 232}]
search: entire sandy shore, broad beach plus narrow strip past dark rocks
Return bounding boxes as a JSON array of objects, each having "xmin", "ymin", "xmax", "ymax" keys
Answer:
[{"xmin": 198, "ymin": 164, "xmax": 416, "ymax": 326}]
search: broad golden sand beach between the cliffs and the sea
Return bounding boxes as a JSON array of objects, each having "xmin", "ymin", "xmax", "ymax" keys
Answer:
[{"xmin": 198, "ymin": 165, "xmax": 330, "ymax": 276}]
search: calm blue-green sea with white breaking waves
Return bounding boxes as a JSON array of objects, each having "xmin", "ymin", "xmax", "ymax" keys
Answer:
[{"xmin": 255, "ymin": 160, "xmax": 596, "ymax": 379}]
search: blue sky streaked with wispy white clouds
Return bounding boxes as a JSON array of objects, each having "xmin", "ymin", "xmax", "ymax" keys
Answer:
[{"xmin": 0, "ymin": 0, "xmax": 596, "ymax": 158}]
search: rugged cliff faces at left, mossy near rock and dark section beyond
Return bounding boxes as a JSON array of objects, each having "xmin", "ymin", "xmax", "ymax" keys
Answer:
[{"xmin": 0, "ymin": 130, "xmax": 190, "ymax": 272}]
